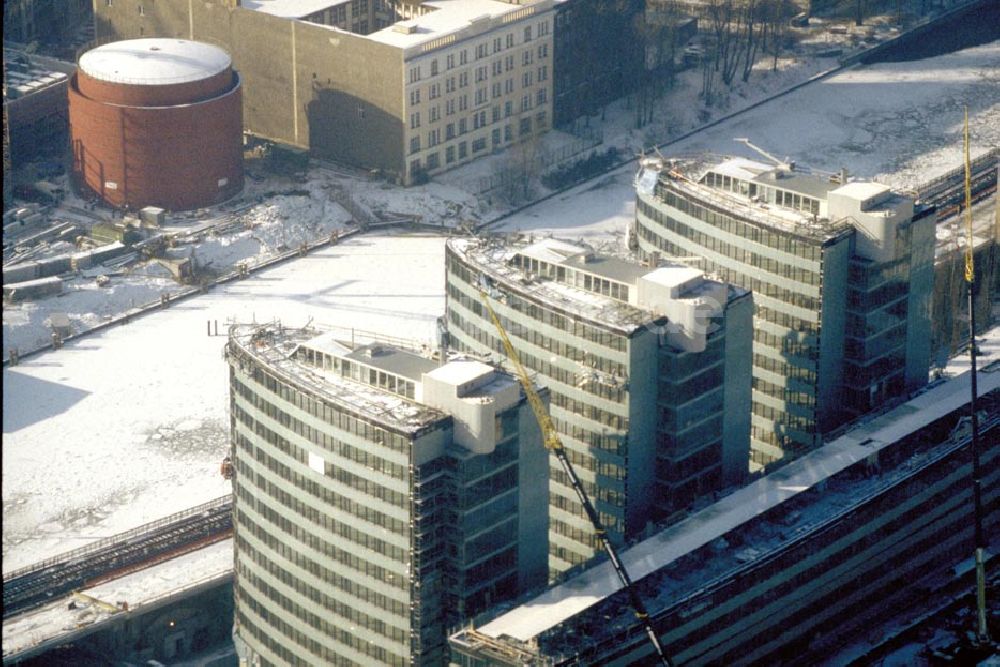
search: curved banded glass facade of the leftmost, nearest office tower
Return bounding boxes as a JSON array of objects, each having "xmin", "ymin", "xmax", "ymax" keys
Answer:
[{"xmin": 227, "ymin": 330, "xmax": 540, "ymax": 665}]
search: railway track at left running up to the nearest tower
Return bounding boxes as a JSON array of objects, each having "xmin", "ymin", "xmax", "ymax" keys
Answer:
[{"xmin": 3, "ymin": 496, "xmax": 233, "ymax": 618}]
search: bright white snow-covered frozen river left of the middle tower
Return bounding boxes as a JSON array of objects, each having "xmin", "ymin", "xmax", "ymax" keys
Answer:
[{"xmin": 3, "ymin": 236, "xmax": 444, "ymax": 572}]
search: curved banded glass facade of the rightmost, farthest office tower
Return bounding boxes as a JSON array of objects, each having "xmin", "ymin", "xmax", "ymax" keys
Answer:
[{"xmin": 636, "ymin": 172, "xmax": 924, "ymax": 466}]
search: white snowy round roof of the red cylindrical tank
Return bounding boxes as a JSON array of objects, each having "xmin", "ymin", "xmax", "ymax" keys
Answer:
[{"xmin": 80, "ymin": 38, "xmax": 232, "ymax": 86}]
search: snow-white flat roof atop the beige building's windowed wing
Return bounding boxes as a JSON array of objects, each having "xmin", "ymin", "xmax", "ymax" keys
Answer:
[{"xmin": 368, "ymin": 0, "xmax": 530, "ymax": 49}]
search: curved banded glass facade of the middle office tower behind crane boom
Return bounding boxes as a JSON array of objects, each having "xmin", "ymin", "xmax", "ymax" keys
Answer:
[{"xmin": 446, "ymin": 244, "xmax": 725, "ymax": 578}]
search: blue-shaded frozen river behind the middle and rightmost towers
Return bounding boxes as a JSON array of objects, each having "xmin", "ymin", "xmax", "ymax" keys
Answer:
[{"xmin": 501, "ymin": 41, "xmax": 1000, "ymax": 237}]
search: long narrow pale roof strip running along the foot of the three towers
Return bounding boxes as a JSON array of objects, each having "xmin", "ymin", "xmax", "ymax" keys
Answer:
[{"xmin": 478, "ymin": 344, "xmax": 1000, "ymax": 642}]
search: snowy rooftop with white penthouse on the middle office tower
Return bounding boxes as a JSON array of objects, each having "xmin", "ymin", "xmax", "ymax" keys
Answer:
[{"xmin": 449, "ymin": 238, "xmax": 729, "ymax": 352}]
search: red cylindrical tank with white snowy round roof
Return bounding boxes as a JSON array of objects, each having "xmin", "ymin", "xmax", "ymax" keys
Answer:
[{"xmin": 69, "ymin": 39, "xmax": 243, "ymax": 211}]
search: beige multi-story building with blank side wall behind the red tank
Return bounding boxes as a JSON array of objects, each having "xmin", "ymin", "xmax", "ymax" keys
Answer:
[{"xmin": 97, "ymin": 0, "xmax": 554, "ymax": 184}]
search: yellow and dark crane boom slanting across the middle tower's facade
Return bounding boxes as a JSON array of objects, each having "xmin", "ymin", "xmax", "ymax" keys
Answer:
[{"xmin": 479, "ymin": 286, "xmax": 673, "ymax": 667}]
